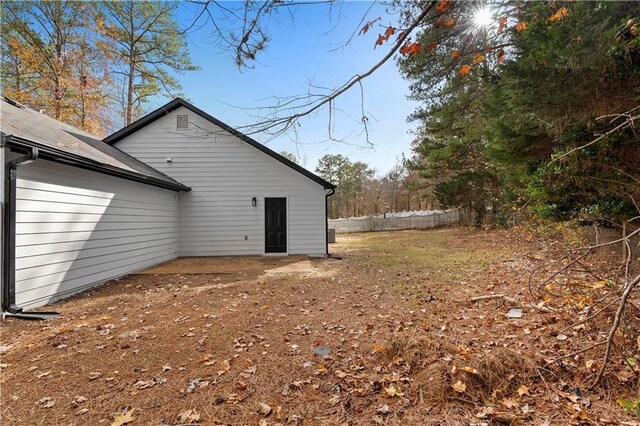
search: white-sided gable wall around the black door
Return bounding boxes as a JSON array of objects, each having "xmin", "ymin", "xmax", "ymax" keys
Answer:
[{"xmin": 115, "ymin": 107, "xmax": 326, "ymax": 256}]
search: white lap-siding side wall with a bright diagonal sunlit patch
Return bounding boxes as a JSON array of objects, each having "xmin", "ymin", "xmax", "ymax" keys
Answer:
[{"xmin": 16, "ymin": 160, "xmax": 178, "ymax": 307}]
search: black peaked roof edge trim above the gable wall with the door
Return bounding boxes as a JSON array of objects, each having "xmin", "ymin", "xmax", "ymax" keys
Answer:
[{"xmin": 104, "ymin": 98, "xmax": 336, "ymax": 189}]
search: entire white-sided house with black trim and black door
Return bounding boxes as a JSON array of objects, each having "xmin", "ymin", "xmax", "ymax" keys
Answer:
[{"xmin": 0, "ymin": 99, "xmax": 335, "ymax": 312}]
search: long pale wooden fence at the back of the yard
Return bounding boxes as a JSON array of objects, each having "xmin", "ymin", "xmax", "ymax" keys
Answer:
[{"xmin": 329, "ymin": 210, "xmax": 461, "ymax": 234}]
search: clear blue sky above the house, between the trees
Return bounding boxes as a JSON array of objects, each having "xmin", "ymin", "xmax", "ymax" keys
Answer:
[{"xmin": 165, "ymin": 2, "xmax": 417, "ymax": 175}]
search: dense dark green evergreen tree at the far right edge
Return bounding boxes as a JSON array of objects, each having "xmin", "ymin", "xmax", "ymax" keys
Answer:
[{"xmin": 486, "ymin": 2, "xmax": 640, "ymax": 223}]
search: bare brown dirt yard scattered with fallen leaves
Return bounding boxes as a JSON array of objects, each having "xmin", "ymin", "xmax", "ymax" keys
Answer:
[{"xmin": 0, "ymin": 228, "xmax": 640, "ymax": 425}]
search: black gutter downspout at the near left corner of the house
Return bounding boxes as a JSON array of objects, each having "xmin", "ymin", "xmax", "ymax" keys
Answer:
[{"xmin": 0, "ymin": 134, "xmax": 58, "ymax": 319}]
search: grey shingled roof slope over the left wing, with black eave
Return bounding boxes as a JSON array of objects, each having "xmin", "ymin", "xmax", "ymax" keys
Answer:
[{"xmin": 0, "ymin": 98, "xmax": 190, "ymax": 191}]
